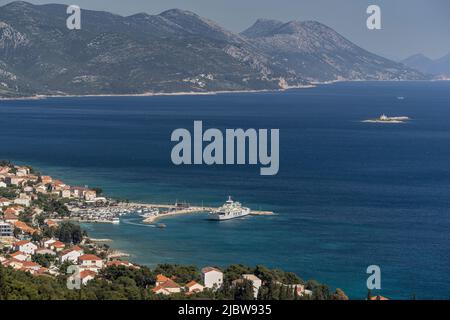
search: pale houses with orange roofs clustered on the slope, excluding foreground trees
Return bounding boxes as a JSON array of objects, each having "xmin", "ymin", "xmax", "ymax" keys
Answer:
[{"xmin": 0, "ymin": 161, "xmax": 342, "ymax": 299}]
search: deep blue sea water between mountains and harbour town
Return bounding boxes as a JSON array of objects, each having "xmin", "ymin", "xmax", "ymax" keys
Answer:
[{"xmin": 0, "ymin": 82, "xmax": 450, "ymax": 299}]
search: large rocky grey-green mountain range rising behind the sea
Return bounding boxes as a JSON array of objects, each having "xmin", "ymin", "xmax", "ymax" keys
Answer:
[{"xmin": 0, "ymin": 1, "xmax": 426, "ymax": 97}]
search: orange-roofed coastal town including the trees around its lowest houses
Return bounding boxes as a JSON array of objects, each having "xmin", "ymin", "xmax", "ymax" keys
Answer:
[{"xmin": 0, "ymin": 161, "xmax": 352, "ymax": 300}]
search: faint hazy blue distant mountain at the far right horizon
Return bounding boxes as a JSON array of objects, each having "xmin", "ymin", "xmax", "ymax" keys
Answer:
[{"xmin": 401, "ymin": 53, "xmax": 450, "ymax": 78}]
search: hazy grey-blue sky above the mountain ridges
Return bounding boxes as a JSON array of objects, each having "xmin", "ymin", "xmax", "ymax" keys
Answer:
[{"xmin": 0, "ymin": 0, "xmax": 450, "ymax": 59}]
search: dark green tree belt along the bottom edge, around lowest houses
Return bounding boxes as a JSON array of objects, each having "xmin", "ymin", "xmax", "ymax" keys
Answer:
[{"xmin": 0, "ymin": 262, "xmax": 345, "ymax": 300}]
